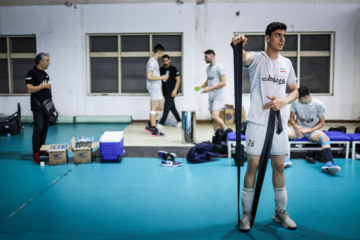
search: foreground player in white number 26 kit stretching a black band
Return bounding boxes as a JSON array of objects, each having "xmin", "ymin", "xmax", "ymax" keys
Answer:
[{"xmin": 232, "ymin": 22, "xmax": 298, "ymax": 232}]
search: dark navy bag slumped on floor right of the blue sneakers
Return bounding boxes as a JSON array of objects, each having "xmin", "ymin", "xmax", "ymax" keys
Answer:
[{"xmin": 186, "ymin": 141, "xmax": 219, "ymax": 163}]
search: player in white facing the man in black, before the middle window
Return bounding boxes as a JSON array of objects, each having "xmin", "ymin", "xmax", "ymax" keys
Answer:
[{"xmin": 145, "ymin": 44, "xmax": 169, "ymax": 137}]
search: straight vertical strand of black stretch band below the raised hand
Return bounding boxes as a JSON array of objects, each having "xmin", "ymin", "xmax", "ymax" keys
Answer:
[{"xmin": 231, "ymin": 43, "xmax": 244, "ymax": 223}]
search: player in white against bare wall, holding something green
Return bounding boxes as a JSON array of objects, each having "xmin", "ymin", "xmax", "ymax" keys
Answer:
[{"xmin": 197, "ymin": 49, "xmax": 226, "ymax": 132}]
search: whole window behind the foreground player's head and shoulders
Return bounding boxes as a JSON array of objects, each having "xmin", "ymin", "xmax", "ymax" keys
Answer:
[{"xmin": 235, "ymin": 32, "xmax": 334, "ymax": 95}]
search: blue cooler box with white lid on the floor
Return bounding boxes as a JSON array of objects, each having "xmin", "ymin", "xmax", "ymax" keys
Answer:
[{"xmin": 100, "ymin": 131, "xmax": 124, "ymax": 162}]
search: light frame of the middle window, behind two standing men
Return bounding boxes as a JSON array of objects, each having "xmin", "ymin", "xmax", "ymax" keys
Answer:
[{"xmin": 86, "ymin": 32, "xmax": 184, "ymax": 96}]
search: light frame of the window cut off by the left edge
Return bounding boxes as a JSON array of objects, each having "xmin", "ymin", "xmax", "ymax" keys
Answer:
[{"xmin": 0, "ymin": 34, "xmax": 37, "ymax": 96}]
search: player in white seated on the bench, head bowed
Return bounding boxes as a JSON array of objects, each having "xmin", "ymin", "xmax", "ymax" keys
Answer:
[{"xmin": 288, "ymin": 87, "xmax": 341, "ymax": 175}]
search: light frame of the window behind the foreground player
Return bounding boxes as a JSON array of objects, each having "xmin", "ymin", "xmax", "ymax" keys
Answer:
[{"xmin": 234, "ymin": 31, "xmax": 335, "ymax": 96}]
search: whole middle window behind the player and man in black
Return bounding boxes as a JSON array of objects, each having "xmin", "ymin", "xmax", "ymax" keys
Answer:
[{"xmin": 87, "ymin": 33, "xmax": 182, "ymax": 95}]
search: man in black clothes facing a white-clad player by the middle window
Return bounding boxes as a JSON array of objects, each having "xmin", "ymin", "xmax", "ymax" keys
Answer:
[{"xmin": 157, "ymin": 55, "xmax": 181, "ymax": 129}]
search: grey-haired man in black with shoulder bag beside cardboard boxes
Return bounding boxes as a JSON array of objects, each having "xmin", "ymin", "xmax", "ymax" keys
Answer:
[{"xmin": 26, "ymin": 52, "xmax": 51, "ymax": 163}]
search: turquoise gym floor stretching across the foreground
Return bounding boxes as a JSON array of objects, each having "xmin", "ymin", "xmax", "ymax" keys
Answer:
[{"xmin": 0, "ymin": 124, "xmax": 360, "ymax": 240}]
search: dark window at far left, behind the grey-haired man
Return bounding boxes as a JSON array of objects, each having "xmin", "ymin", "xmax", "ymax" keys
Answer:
[{"xmin": 0, "ymin": 35, "xmax": 36, "ymax": 95}]
